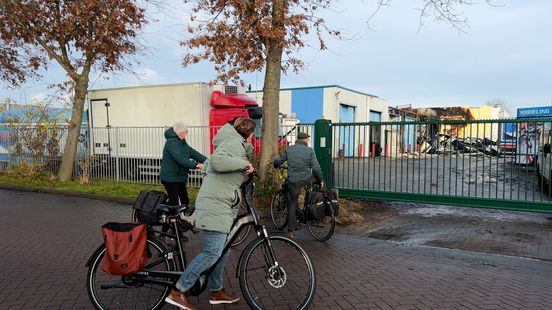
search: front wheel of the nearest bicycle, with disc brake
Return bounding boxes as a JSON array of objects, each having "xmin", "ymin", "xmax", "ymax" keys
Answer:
[{"xmin": 238, "ymin": 235, "xmax": 316, "ymax": 309}]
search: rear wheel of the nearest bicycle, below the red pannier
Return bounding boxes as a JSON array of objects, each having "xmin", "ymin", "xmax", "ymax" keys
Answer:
[{"xmin": 86, "ymin": 236, "xmax": 176, "ymax": 310}]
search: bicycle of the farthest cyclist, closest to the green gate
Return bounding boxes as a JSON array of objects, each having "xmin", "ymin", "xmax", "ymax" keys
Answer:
[{"xmin": 270, "ymin": 178, "xmax": 335, "ymax": 241}]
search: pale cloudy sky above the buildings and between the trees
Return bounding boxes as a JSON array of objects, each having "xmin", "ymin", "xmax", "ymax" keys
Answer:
[{"xmin": 0, "ymin": 0, "xmax": 552, "ymax": 112}]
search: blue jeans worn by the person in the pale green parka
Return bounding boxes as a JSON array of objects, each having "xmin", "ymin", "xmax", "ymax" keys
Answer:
[{"xmin": 176, "ymin": 230, "xmax": 228, "ymax": 292}]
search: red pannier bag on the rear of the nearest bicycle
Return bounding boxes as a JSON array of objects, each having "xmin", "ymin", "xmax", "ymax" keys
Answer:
[{"xmin": 102, "ymin": 222, "xmax": 148, "ymax": 275}]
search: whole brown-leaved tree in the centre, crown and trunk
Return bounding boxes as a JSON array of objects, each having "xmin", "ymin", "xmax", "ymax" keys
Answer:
[{"xmin": 182, "ymin": 0, "xmax": 340, "ymax": 182}]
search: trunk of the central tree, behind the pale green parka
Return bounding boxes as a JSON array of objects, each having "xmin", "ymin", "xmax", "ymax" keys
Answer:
[{"xmin": 259, "ymin": 0, "xmax": 285, "ymax": 184}]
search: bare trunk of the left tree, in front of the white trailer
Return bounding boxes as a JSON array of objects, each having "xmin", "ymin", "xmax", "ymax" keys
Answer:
[{"xmin": 58, "ymin": 76, "xmax": 88, "ymax": 182}]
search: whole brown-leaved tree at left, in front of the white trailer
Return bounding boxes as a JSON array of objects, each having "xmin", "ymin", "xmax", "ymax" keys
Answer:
[{"xmin": 0, "ymin": 0, "xmax": 146, "ymax": 181}]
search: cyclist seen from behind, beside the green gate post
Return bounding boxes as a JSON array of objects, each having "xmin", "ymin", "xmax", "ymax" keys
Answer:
[{"xmin": 274, "ymin": 132, "xmax": 324, "ymax": 237}]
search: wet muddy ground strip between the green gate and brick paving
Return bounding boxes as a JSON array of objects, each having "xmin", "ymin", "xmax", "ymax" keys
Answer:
[{"xmin": 338, "ymin": 199, "xmax": 552, "ymax": 260}]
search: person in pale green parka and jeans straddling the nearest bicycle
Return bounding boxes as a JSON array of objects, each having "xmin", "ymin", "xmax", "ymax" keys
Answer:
[{"xmin": 165, "ymin": 118, "xmax": 255, "ymax": 309}]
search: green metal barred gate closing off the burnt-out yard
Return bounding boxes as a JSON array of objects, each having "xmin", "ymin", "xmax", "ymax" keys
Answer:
[{"xmin": 329, "ymin": 118, "xmax": 552, "ymax": 213}]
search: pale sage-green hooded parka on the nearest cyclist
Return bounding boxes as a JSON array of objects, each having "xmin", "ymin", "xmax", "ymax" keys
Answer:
[{"xmin": 195, "ymin": 124, "xmax": 251, "ymax": 233}]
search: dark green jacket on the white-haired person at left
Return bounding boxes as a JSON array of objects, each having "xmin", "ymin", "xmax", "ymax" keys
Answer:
[{"xmin": 159, "ymin": 128, "xmax": 207, "ymax": 183}]
